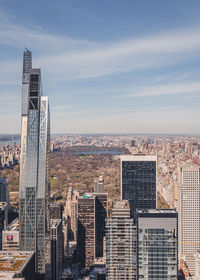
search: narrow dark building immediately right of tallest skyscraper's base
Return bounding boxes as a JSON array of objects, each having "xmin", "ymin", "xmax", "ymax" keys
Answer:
[{"xmin": 51, "ymin": 219, "xmax": 63, "ymax": 280}]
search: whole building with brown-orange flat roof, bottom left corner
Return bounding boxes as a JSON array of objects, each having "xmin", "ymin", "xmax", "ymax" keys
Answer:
[{"xmin": 0, "ymin": 251, "xmax": 35, "ymax": 280}]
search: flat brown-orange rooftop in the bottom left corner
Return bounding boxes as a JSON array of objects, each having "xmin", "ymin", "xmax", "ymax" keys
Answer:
[{"xmin": 0, "ymin": 251, "xmax": 34, "ymax": 272}]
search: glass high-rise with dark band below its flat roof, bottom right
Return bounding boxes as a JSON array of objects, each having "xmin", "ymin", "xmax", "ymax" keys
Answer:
[{"xmin": 136, "ymin": 209, "xmax": 178, "ymax": 280}]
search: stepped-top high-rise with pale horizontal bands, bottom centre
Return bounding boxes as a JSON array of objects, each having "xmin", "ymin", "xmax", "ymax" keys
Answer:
[{"xmin": 105, "ymin": 200, "xmax": 137, "ymax": 280}]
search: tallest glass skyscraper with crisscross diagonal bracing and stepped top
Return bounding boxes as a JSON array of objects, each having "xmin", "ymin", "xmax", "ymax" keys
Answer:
[{"xmin": 19, "ymin": 50, "xmax": 50, "ymax": 274}]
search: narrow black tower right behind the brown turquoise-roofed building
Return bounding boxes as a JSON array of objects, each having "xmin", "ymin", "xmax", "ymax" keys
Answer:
[{"xmin": 95, "ymin": 193, "xmax": 108, "ymax": 258}]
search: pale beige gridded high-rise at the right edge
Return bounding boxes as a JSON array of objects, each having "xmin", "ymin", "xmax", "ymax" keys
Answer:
[{"xmin": 178, "ymin": 163, "xmax": 200, "ymax": 274}]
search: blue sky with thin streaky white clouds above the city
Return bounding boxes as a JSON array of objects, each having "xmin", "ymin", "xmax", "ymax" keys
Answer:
[{"xmin": 0, "ymin": 0, "xmax": 200, "ymax": 134}]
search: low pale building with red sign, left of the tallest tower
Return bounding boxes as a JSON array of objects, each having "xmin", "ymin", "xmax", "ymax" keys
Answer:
[{"xmin": 2, "ymin": 218, "xmax": 19, "ymax": 251}]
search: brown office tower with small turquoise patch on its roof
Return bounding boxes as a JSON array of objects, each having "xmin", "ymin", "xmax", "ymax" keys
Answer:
[{"xmin": 77, "ymin": 194, "xmax": 96, "ymax": 267}]
